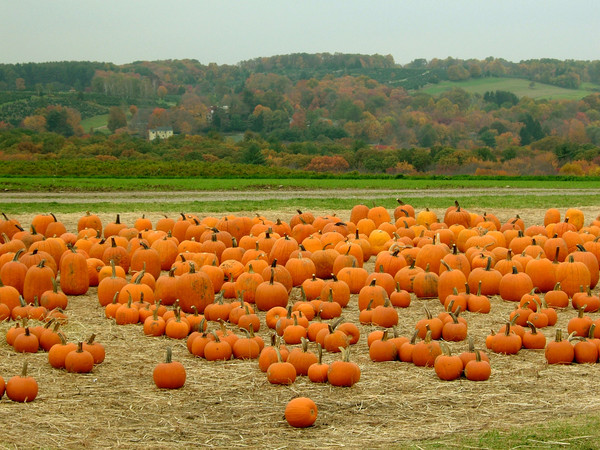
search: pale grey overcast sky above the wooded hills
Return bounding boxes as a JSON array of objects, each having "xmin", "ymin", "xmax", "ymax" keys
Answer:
[{"xmin": 0, "ymin": 0, "xmax": 600, "ymax": 64}]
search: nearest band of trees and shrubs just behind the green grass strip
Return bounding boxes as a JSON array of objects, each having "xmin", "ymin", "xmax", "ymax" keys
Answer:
[{"xmin": 0, "ymin": 129, "xmax": 600, "ymax": 176}]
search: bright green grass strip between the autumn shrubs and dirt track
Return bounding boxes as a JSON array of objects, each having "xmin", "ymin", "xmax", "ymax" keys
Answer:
[{"xmin": 0, "ymin": 177, "xmax": 600, "ymax": 192}]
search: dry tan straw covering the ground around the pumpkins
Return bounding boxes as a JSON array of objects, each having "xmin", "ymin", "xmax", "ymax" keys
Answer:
[{"xmin": 0, "ymin": 208, "xmax": 600, "ymax": 448}]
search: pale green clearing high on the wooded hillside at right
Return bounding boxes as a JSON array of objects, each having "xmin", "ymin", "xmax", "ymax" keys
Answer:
[{"xmin": 421, "ymin": 77, "xmax": 599, "ymax": 100}]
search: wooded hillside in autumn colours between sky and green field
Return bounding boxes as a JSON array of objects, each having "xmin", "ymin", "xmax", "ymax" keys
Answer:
[{"xmin": 0, "ymin": 53, "xmax": 600, "ymax": 173}]
